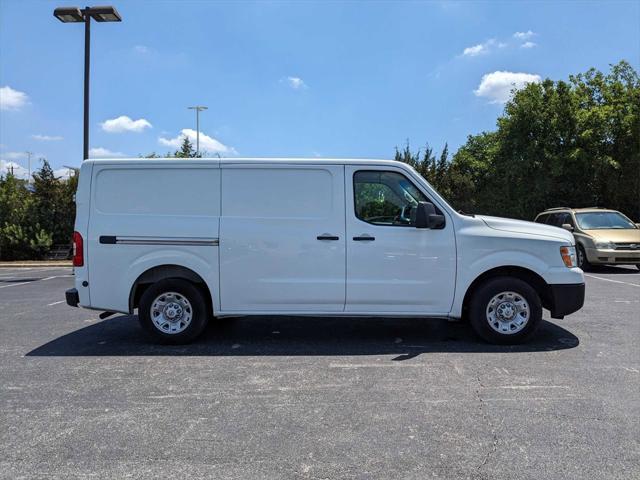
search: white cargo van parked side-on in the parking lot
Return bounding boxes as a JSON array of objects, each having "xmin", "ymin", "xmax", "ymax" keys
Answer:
[{"xmin": 66, "ymin": 158, "xmax": 584, "ymax": 344}]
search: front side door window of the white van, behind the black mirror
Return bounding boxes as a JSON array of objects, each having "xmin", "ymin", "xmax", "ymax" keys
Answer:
[{"xmin": 353, "ymin": 170, "xmax": 430, "ymax": 226}]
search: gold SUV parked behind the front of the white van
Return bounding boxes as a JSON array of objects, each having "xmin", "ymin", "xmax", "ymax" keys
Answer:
[{"xmin": 534, "ymin": 207, "xmax": 640, "ymax": 270}]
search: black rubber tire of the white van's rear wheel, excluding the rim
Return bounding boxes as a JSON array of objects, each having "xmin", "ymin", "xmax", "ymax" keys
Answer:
[{"xmin": 138, "ymin": 278, "xmax": 209, "ymax": 345}]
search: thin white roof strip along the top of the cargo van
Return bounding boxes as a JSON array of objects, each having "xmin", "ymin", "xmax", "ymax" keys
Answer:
[{"xmin": 83, "ymin": 157, "xmax": 407, "ymax": 166}]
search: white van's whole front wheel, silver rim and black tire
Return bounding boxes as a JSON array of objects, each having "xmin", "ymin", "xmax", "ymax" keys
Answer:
[{"xmin": 469, "ymin": 277, "xmax": 542, "ymax": 345}]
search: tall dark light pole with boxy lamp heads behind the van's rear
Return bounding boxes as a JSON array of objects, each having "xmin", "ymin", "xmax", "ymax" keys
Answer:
[{"xmin": 53, "ymin": 6, "xmax": 122, "ymax": 160}]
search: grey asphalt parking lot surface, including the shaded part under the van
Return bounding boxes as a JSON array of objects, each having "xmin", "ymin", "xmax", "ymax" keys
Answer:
[{"xmin": 0, "ymin": 268, "xmax": 640, "ymax": 480}]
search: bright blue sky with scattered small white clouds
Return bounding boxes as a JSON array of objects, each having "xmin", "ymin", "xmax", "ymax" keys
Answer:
[{"xmin": 0, "ymin": 0, "xmax": 640, "ymax": 176}]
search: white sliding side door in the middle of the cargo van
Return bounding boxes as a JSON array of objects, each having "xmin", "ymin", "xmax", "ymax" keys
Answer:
[{"xmin": 219, "ymin": 164, "xmax": 346, "ymax": 313}]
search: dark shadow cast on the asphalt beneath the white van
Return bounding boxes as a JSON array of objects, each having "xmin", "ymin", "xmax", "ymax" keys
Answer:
[{"xmin": 27, "ymin": 315, "xmax": 580, "ymax": 360}]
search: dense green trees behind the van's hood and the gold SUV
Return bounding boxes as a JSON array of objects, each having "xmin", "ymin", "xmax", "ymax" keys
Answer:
[{"xmin": 396, "ymin": 61, "xmax": 640, "ymax": 220}]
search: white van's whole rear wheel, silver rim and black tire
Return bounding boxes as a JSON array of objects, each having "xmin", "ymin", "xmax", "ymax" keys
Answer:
[{"xmin": 138, "ymin": 278, "xmax": 207, "ymax": 344}]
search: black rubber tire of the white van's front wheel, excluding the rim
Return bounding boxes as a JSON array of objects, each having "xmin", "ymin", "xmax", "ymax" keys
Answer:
[{"xmin": 469, "ymin": 277, "xmax": 542, "ymax": 345}]
